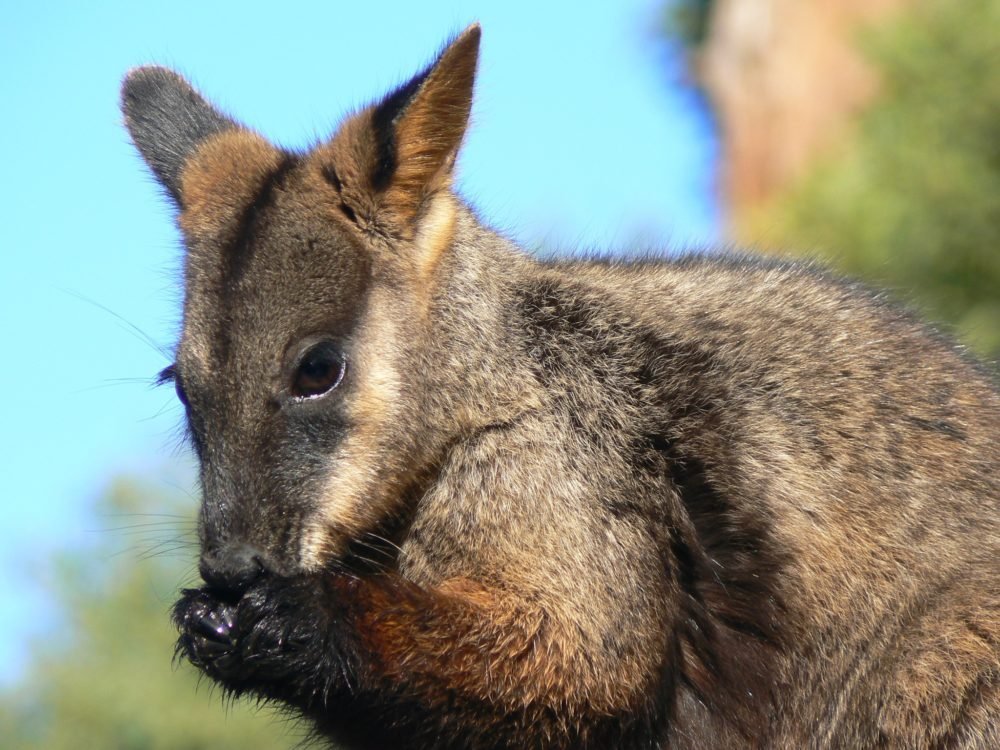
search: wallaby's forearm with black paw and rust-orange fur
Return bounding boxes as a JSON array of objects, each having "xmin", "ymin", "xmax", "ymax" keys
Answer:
[{"xmin": 176, "ymin": 573, "xmax": 656, "ymax": 747}]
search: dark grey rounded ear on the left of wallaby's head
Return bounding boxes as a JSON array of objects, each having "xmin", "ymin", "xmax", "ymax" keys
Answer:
[{"xmin": 121, "ymin": 66, "xmax": 239, "ymax": 205}]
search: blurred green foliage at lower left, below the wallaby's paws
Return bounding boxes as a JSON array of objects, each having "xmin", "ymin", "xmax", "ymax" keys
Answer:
[{"xmin": 0, "ymin": 482, "xmax": 303, "ymax": 750}]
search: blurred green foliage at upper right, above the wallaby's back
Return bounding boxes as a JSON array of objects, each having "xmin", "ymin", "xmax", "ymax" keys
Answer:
[{"xmin": 749, "ymin": 0, "xmax": 1000, "ymax": 358}]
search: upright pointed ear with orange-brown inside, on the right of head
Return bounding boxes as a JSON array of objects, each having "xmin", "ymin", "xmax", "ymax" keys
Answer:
[{"xmin": 321, "ymin": 24, "xmax": 481, "ymax": 231}]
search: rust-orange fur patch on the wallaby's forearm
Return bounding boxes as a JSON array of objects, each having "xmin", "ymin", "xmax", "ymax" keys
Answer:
[{"xmin": 346, "ymin": 579, "xmax": 655, "ymax": 722}]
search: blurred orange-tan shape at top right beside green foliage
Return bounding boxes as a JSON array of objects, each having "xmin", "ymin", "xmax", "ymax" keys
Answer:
[{"xmin": 698, "ymin": 0, "xmax": 914, "ymax": 213}]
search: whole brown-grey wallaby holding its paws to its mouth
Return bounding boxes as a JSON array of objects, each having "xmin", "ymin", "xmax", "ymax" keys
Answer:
[{"xmin": 122, "ymin": 25, "xmax": 1000, "ymax": 749}]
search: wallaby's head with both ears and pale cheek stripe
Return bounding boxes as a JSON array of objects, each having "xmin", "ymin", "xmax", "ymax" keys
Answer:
[{"xmin": 123, "ymin": 25, "xmax": 480, "ymax": 588}]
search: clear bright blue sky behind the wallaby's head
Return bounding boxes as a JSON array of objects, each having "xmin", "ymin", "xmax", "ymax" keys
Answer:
[{"xmin": 0, "ymin": 0, "xmax": 719, "ymax": 680}]
